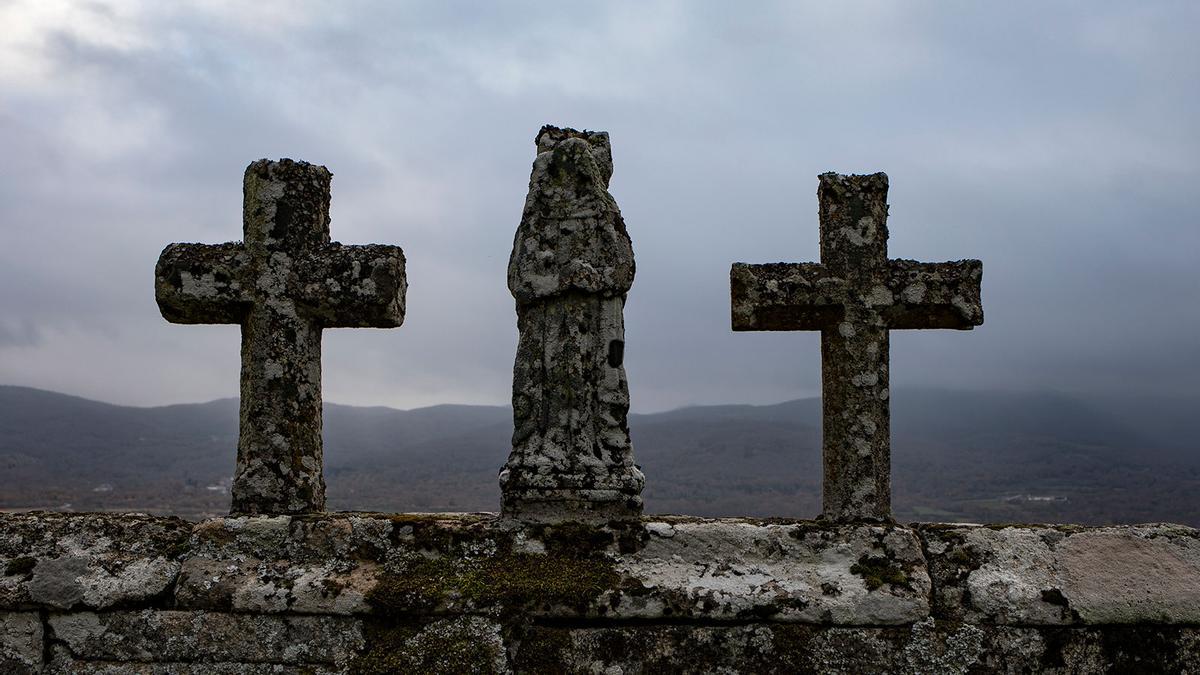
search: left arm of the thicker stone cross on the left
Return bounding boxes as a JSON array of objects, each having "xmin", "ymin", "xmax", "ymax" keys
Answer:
[{"xmin": 154, "ymin": 243, "xmax": 250, "ymax": 323}]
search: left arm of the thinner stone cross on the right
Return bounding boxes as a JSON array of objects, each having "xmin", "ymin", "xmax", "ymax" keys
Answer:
[{"xmin": 730, "ymin": 263, "xmax": 846, "ymax": 330}]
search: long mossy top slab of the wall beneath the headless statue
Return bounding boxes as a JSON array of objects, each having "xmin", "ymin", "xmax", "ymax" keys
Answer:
[{"xmin": 164, "ymin": 514, "xmax": 929, "ymax": 625}]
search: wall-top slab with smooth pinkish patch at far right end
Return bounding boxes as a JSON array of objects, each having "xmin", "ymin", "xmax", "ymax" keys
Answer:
[{"xmin": 923, "ymin": 525, "xmax": 1200, "ymax": 626}]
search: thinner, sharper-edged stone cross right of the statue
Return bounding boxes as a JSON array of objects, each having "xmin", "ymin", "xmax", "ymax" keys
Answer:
[{"xmin": 730, "ymin": 173, "xmax": 983, "ymax": 520}]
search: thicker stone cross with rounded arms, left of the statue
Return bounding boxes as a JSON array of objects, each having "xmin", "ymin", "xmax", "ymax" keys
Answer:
[{"xmin": 155, "ymin": 160, "xmax": 407, "ymax": 514}]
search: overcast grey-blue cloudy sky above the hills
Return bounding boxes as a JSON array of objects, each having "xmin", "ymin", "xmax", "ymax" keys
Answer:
[{"xmin": 0, "ymin": 0, "xmax": 1200, "ymax": 411}]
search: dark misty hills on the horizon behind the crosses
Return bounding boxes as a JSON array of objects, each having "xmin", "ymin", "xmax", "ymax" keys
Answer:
[{"xmin": 0, "ymin": 386, "xmax": 1200, "ymax": 525}]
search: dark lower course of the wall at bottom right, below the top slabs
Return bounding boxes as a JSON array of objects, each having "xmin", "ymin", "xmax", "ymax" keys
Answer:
[{"xmin": 512, "ymin": 620, "xmax": 1200, "ymax": 675}]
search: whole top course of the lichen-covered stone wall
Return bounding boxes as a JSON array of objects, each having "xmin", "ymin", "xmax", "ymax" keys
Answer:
[{"xmin": 0, "ymin": 512, "xmax": 1200, "ymax": 626}]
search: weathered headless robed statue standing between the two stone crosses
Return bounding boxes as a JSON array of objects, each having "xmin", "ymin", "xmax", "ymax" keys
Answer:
[{"xmin": 500, "ymin": 126, "xmax": 646, "ymax": 520}]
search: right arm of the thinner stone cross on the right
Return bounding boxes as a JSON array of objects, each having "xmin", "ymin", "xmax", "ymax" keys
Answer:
[{"xmin": 883, "ymin": 259, "xmax": 983, "ymax": 330}]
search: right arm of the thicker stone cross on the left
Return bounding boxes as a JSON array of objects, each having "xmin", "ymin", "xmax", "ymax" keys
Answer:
[{"xmin": 301, "ymin": 243, "xmax": 408, "ymax": 328}]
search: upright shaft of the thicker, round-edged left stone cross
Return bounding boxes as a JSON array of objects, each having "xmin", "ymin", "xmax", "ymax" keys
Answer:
[{"xmin": 232, "ymin": 162, "xmax": 332, "ymax": 513}]
